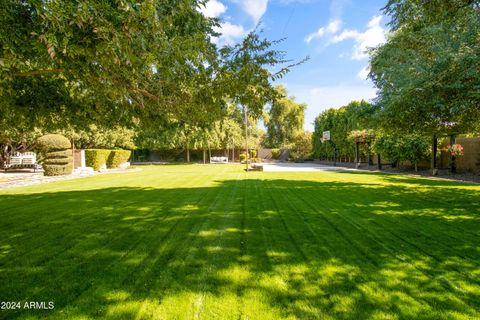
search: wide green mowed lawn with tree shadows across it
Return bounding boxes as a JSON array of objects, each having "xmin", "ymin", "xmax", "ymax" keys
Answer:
[{"xmin": 0, "ymin": 165, "xmax": 480, "ymax": 319}]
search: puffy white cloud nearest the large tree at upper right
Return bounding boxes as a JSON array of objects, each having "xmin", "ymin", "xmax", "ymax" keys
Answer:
[{"xmin": 330, "ymin": 16, "xmax": 386, "ymax": 60}]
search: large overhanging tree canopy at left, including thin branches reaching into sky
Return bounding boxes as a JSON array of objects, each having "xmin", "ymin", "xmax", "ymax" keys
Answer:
[{"xmin": 0, "ymin": 0, "xmax": 300, "ymax": 136}]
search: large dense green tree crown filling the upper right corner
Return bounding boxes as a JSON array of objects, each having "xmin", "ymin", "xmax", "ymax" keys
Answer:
[{"xmin": 370, "ymin": 0, "xmax": 480, "ymax": 134}]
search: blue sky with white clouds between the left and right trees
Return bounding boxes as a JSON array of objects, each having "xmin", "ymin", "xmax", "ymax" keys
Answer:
[{"xmin": 202, "ymin": 0, "xmax": 387, "ymax": 131}]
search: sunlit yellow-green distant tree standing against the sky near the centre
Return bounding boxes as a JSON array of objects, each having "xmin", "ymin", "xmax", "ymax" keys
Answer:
[{"xmin": 265, "ymin": 85, "xmax": 307, "ymax": 148}]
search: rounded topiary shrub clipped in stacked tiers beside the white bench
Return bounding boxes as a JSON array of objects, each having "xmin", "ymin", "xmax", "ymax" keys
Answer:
[{"xmin": 37, "ymin": 134, "xmax": 73, "ymax": 176}]
